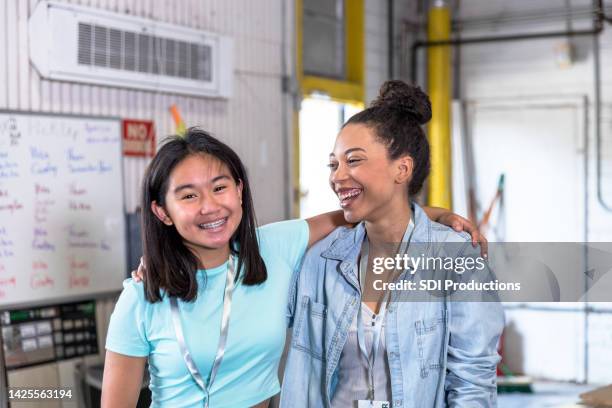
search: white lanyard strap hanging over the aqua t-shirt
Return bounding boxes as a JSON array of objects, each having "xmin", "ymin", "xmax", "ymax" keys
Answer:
[{"xmin": 170, "ymin": 255, "xmax": 236, "ymax": 408}]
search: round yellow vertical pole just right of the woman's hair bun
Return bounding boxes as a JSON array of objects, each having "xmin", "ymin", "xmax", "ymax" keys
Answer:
[{"xmin": 427, "ymin": 0, "xmax": 452, "ymax": 209}]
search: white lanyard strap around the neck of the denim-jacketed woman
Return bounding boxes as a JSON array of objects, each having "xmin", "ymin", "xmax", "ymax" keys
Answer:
[{"xmin": 357, "ymin": 219, "xmax": 414, "ymax": 401}]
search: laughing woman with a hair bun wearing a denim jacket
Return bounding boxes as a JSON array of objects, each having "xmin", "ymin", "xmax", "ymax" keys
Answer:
[{"xmin": 281, "ymin": 81, "xmax": 504, "ymax": 408}]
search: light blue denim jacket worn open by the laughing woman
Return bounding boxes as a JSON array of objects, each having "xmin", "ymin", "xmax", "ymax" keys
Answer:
[{"xmin": 280, "ymin": 204, "xmax": 504, "ymax": 408}]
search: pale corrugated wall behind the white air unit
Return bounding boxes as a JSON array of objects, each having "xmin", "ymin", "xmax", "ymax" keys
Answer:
[{"xmin": 0, "ymin": 0, "xmax": 286, "ymax": 223}]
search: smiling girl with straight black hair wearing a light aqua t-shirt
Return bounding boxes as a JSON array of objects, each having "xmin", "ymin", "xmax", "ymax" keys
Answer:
[{"xmin": 102, "ymin": 129, "xmax": 478, "ymax": 408}]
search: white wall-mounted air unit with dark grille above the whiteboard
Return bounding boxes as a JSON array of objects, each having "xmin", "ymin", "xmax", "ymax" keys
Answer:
[{"xmin": 30, "ymin": 2, "xmax": 233, "ymax": 97}]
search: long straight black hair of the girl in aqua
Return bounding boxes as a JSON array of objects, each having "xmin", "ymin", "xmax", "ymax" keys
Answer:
[{"xmin": 141, "ymin": 128, "xmax": 268, "ymax": 302}]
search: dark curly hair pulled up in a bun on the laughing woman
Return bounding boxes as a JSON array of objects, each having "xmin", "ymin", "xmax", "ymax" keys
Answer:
[{"xmin": 343, "ymin": 80, "xmax": 431, "ymax": 196}]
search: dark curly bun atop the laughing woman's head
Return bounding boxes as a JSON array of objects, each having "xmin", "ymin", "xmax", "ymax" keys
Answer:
[{"xmin": 371, "ymin": 80, "xmax": 431, "ymax": 125}]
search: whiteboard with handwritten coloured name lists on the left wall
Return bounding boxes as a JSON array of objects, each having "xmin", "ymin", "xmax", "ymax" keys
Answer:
[{"xmin": 0, "ymin": 112, "xmax": 126, "ymax": 306}]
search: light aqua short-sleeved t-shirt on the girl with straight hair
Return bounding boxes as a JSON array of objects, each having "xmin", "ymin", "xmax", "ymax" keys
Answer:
[{"xmin": 106, "ymin": 220, "xmax": 309, "ymax": 408}]
